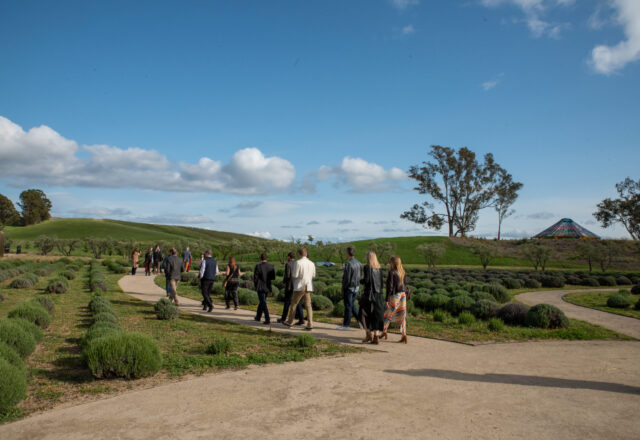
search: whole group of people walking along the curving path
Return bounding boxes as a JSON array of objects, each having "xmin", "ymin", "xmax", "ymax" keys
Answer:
[{"xmin": 131, "ymin": 246, "xmax": 409, "ymax": 344}]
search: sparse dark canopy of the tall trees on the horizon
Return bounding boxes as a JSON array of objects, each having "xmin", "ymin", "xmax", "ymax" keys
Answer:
[{"xmin": 400, "ymin": 145, "xmax": 519, "ymax": 237}]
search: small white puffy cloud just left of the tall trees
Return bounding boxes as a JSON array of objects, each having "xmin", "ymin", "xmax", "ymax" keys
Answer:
[{"xmin": 315, "ymin": 156, "xmax": 407, "ymax": 192}]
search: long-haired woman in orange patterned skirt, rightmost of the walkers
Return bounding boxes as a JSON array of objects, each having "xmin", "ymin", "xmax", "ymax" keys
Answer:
[{"xmin": 382, "ymin": 257, "xmax": 407, "ymax": 344}]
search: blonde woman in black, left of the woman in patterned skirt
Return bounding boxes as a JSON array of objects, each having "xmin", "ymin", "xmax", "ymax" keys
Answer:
[{"xmin": 359, "ymin": 251, "xmax": 385, "ymax": 344}]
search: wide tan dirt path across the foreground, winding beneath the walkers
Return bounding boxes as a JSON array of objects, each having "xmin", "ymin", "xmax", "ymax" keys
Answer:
[{"xmin": 5, "ymin": 276, "xmax": 640, "ymax": 440}]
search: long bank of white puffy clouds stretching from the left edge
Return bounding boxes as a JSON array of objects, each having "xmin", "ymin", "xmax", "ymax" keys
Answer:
[{"xmin": 0, "ymin": 116, "xmax": 296, "ymax": 195}]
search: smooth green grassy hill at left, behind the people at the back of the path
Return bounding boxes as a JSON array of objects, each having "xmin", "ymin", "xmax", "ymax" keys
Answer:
[{"xmin": 5, "ymin": 218, "xmax": 256, "ymax": 242}]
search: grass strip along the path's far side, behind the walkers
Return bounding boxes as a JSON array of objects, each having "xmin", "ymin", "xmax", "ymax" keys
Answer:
[{"xmin": 155, "ymin": 269, "xmax": 633, "ymax": 344}]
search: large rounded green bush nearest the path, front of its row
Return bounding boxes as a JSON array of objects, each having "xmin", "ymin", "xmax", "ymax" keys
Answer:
[{"xmin": 85, "ymin": 332, "xmax": 162, "ymax": 379}]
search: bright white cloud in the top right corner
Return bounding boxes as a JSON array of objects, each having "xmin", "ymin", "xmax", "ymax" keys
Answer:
[{"xmin": 590, "ymin": 0, "xmax": 640, "ymax": 75}]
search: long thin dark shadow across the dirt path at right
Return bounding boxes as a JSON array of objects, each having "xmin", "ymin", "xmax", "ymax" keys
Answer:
[{"xmin": 384, "ymin": 368, "xmax": 640, "ymax": 395}]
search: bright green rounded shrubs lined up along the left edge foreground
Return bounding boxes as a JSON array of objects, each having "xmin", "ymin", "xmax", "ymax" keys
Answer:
[{"xmin": 0, "ymin": 297, "xmax": 55, "ymax": 412}]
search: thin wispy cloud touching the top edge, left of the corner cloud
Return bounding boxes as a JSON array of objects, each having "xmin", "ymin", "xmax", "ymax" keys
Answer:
[{"xmin": 480, "ymin": 0, "xmax": 575, "ymax": 38}]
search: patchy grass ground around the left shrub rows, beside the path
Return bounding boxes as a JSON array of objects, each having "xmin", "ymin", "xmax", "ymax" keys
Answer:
[{"xmin": 0, "ymin": 258, "xmax": 356, "ymax": 422}]
